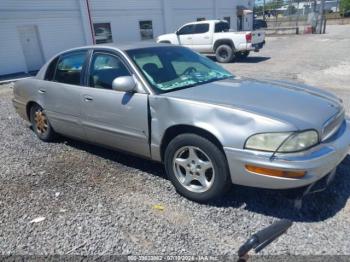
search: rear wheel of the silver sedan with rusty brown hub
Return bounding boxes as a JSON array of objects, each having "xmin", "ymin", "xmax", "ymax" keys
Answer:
[{"xmin": 30, "ymin": 104, "xmax": 56, "ymax": 142}]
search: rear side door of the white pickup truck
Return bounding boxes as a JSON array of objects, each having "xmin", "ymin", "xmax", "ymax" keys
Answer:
[{"xmin": 191, "ymin": 23, "xmax": 213, "ymax": 52}]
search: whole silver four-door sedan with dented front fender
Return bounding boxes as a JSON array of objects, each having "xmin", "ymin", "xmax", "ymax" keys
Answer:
[{"xmin": 13, "ymin": 44, "xmax": 350, "ymax": 202}]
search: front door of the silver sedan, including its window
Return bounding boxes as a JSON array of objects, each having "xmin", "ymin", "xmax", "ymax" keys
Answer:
[{"xmin": 81, "ymin": 52, "xmax": 150, "ymax": 156}]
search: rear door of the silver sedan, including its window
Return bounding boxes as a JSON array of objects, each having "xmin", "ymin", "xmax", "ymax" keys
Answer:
[{"xmin": 42, "ymin": 50, "xmax": 88, "ymax": 139}]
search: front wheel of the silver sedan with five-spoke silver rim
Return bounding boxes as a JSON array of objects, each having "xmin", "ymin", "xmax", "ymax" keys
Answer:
[{"xmin": 164, "ymin": 134, "xmax": 231, "ymax": 203}]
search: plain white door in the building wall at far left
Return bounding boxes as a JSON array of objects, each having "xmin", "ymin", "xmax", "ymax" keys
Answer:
[{"xmin": 17, "ymin": 25, "xmax": 44, "ymax": 71}]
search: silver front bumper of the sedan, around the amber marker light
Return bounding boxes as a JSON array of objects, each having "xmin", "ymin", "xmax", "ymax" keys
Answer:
[{"xmin": 224, "ymin": 121, "xmax": 350, "ymax": 189}]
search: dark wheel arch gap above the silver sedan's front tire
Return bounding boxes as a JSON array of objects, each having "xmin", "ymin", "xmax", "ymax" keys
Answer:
[{"xmin": 160, "ymin": 124, "xmax": 225, "ymax": 162}]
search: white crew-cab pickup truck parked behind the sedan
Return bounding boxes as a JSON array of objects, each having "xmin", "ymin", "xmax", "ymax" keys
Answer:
[{"xmin": 157, "ymin": 20, "xmax": 265, "ymax": 63}]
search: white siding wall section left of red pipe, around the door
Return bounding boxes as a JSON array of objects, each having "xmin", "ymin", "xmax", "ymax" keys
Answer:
[{"xmin": 0, "ymin": 0, "xmax": 85, "ymax": 75}]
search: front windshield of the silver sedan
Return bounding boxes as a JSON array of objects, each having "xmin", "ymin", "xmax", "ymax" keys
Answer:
[{"xmin": 127, "ymin": 46, "xmax": 233, "ymax": 93}]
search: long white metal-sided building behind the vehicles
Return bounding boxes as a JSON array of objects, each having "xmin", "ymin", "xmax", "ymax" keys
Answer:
[{"xmin": 0, "ymin": 0, "xmax": 254, "ymax": 75}]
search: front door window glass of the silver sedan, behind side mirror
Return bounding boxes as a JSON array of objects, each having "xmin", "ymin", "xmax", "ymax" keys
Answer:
[{"xmin": 89, "ymin": 53, "xmax": 131, "ymax": 89}]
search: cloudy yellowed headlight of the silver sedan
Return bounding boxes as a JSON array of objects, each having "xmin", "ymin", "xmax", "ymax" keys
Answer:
[{"xmin": 245, "ymin": 130, "xmax": 318, "ymax": 153}]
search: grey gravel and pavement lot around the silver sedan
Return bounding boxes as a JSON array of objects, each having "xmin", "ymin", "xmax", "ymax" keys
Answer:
[{"xmin": 0, "ymin": 26, "xmax": 350, "ymax": 255}]
